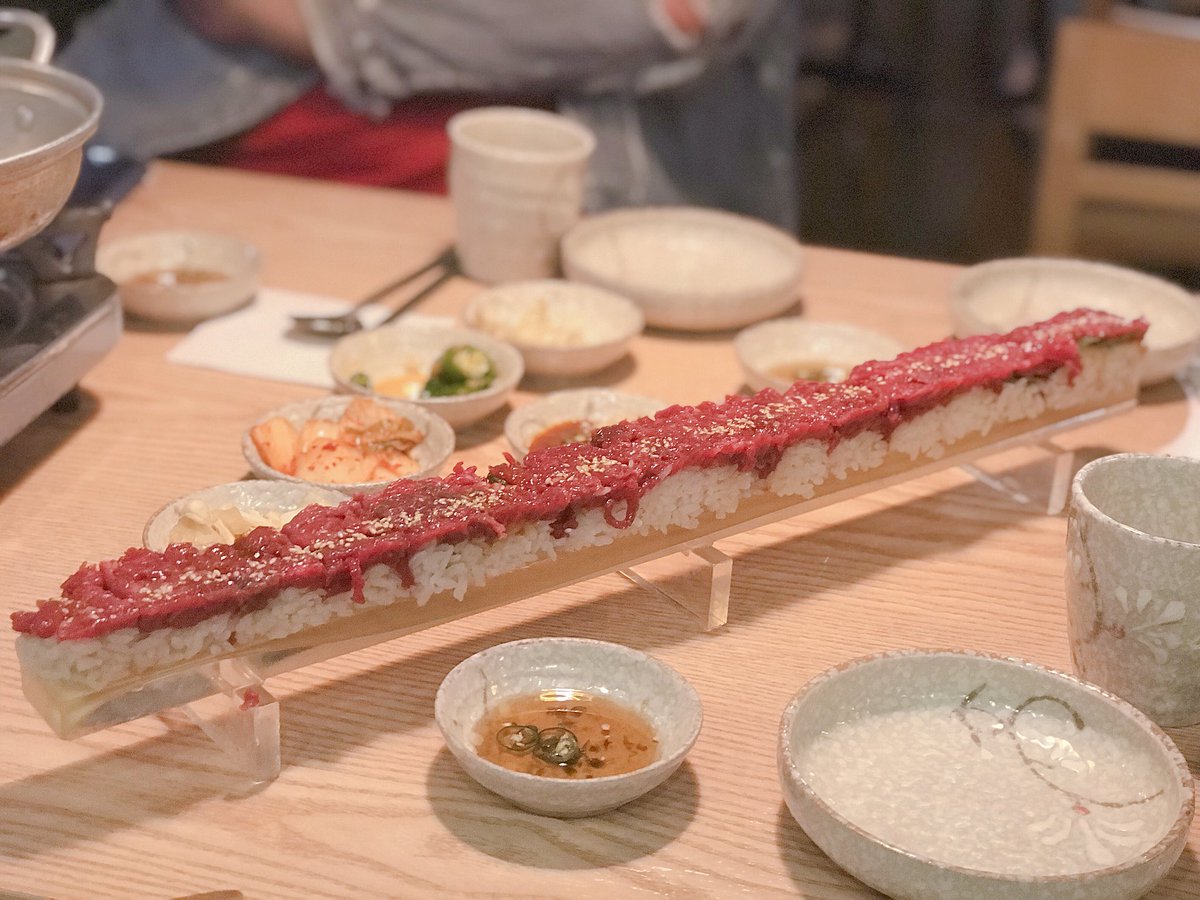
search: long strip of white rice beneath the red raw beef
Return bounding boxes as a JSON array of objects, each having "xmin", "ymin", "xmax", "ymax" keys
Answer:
[{"xmin": 17, "ymin": 343, "xmax": 1140, "ymax": 690}]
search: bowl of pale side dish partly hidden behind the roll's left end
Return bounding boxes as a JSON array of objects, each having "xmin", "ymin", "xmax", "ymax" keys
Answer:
[{"xmin": 142, "ymin": 480, "xmax": 346, "ymax": 551}]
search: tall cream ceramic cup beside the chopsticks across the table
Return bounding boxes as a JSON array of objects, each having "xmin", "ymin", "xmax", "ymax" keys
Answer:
[{"xmin": 446, "ymin": 107, "xmax": 595, "ymax": 283}]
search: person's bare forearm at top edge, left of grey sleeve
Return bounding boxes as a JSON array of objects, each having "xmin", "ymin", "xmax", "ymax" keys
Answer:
[{"xmin": 174, "ymin": 0, "xmax": 312, "ymax": 61}]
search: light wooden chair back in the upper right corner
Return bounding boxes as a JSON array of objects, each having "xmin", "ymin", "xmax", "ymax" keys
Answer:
[{"xmin": 1032, "ymin": 15, "xmax": 1200, "ymax": 269}]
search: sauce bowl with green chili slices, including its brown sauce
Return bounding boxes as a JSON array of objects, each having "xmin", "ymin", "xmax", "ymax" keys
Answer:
[{"xmin": 434, "ymin": 637, "xmax": 702, "ymax": 818}]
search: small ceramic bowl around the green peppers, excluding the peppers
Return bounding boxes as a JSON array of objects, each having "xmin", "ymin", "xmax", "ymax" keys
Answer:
[{"xmin": 329, "ymin": 320, "xmax": 524, "ymax": 428}]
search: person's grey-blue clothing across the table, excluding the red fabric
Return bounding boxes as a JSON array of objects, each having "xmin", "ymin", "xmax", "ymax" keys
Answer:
[{"xmin": 58, "ymin": 0, "xmax": 799, "ymax": 228}]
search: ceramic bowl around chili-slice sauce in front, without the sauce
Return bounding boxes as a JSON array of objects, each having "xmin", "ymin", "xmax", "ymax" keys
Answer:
[{"xmin": 434, "ymin": 637, "xmax": 703, "ymax": 818}]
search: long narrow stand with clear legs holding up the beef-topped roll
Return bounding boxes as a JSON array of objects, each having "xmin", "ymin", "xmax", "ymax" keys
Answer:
[{"xmin": 23, "ymin": 398, "xmax": 1135, "ymax": 782}]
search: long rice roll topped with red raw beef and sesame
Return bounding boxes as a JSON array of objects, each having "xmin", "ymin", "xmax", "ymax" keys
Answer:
[{"xmin": 12, "ymin": 311, "xmax": 1146, "ymax": 734}]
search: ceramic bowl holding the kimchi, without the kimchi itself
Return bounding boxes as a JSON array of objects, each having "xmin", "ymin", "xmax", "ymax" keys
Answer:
[{"xmin": 241, "ymin": 395, "xmax": 455, "ymax": 493}]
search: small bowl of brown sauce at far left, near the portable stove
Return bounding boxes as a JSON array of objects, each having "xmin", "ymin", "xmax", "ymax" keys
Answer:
[{"xmin": 96, "ymin": 232, "xmax": 259, "ymax": 325}]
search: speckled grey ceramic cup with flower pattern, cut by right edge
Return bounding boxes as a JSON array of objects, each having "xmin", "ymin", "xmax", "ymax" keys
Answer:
[{"xmin": 1067, "ymin": 454, "xmax": 1200, "ymax": 726}]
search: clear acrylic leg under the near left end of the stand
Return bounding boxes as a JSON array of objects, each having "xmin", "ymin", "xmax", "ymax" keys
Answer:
[{"xmin": 182, "ymin": 659, "xmax": 280, "ymax": 784}]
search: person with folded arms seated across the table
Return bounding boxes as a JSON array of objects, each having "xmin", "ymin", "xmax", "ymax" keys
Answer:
[{"xmin": 58, "ymin": 0, "xmax": 799, "ymax": 230}]
